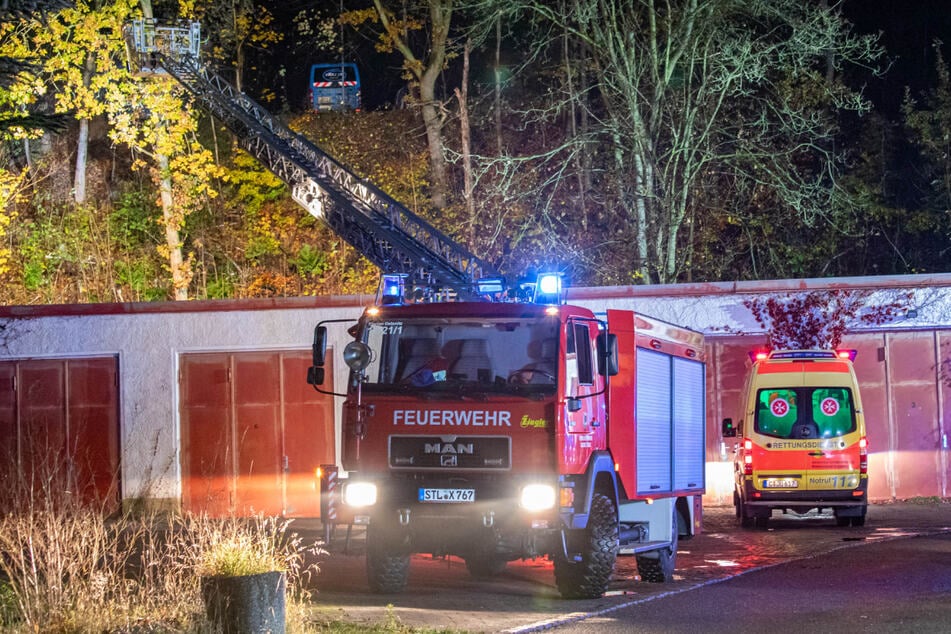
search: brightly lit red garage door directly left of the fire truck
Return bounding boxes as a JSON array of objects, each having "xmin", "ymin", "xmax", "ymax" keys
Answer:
[{"xmin": 181, "ymin": 350, "xmax": 336, "ymax": 517}]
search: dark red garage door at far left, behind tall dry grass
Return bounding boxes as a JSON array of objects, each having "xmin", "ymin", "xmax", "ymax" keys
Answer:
[{"xmin": 0, "ymin": 357, "xmax": 119, "ymax": 510}]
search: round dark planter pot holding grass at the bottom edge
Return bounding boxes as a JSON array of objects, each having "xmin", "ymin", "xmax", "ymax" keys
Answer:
[{"xmin": 201, "ymin": 572, "xmax": 286, "ymax": 634}]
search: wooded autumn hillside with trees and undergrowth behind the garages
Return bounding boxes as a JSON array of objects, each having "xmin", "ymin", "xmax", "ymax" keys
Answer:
[{"xmin": 0, "ymin": 0, "xmax": 951, "ymax": 304}]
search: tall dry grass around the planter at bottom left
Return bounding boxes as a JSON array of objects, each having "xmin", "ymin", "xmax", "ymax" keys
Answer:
[{"xmin": 0, "ymin": 454, "xmax": 322, "ymax": 633}]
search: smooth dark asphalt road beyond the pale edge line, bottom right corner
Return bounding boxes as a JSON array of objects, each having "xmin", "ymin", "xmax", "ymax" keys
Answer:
[{"xmin": 556, "ymin": 534, "xmax": 951, "ymax": 634}]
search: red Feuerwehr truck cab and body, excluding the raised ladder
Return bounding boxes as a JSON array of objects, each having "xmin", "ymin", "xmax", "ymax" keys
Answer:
[{"xmin": 308, "ymin": 278, "xmax": 705, "ymax": 598}]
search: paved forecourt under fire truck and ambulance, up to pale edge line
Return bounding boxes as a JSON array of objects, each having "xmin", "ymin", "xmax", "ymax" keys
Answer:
[{"xmin": 304, "ymin": 503, "xmax": 951, "ymax": 632}]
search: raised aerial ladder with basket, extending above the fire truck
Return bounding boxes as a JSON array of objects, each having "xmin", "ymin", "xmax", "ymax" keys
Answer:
[{"xmin": 125, "ymin": 20, "xmax": 501, "ymax": 299}]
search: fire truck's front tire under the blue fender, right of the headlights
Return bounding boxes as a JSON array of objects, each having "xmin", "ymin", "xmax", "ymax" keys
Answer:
[{"xmin": 555, "ymin": 493, "xmax": 619, "ymax": 599}]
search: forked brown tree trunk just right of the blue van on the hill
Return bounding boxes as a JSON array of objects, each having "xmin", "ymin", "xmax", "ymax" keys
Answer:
[{"xmin": 341, "ymin": 0, "xmax": 453, "ymax": 209}]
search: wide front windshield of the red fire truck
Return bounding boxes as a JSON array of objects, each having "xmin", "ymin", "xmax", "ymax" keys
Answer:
[{"xmin": 363, "ymin": 318, "xmax": 558, "ymax": 392}]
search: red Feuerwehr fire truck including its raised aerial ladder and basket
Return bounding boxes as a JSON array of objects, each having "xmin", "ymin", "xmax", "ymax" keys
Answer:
[{"xmin": 126, "ymin": 20, "xmax": 706, "ymax": 597}]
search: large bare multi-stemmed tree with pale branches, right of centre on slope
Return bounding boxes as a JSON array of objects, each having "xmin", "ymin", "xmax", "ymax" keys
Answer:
[{"xmin": 476, "ymin": 0, "xmax": 879, "ymax": 282}]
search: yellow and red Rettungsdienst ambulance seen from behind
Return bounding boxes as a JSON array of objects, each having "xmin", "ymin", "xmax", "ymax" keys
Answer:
[{"xmin": 722, "ymin": 350, "xmax": 868, "ymax": 528}]
